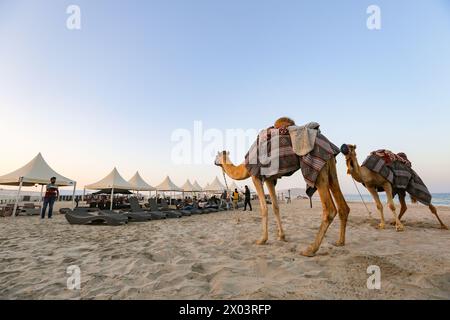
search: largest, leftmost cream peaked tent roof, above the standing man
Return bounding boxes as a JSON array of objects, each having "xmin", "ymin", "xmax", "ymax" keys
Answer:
[{"xmin": 0, "ymin": 153, "xmax": 75, "ymax": 187}]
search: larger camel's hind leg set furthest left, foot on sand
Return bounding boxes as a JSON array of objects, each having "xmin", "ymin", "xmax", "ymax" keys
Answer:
[{"xmin": 301, "ymin": 165, "xmax": 337, "ymax": 257}]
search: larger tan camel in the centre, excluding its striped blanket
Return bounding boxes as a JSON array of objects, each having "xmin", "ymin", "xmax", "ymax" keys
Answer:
[{"xmin": 215, "ymin": 118, "xmax": 350, "ymax": 257}]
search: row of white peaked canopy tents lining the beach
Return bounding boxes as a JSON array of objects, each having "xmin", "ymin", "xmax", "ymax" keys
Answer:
[{"xmin": 0, "ymin": 153, "xmax": 246, "ymax": 215}]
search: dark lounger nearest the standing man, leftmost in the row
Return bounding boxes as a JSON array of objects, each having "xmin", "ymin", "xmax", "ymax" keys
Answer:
[{"xmin": 65, "ymin": 210, "xmax": 128, "ymax": 226}]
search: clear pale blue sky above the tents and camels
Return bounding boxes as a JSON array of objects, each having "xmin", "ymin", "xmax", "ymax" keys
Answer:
[{"xmin": 0, "ymin": 0, "xmax": 450, "ymax": 193}]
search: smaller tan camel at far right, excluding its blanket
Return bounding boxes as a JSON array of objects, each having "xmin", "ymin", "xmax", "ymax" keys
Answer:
[{"xmin": 345, "ymin": 144, "xmax": 448, "ymax": 231}]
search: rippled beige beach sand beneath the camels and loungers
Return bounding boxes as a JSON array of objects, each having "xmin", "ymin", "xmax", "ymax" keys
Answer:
[{"xmin": 0, "ymin": 200, "xmax": 450, "ymax": 299}]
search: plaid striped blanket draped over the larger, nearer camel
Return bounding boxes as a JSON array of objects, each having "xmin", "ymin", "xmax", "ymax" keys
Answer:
[{"xmin": 244, "ymin": 127, "xmax": 340, "ymax": 196}]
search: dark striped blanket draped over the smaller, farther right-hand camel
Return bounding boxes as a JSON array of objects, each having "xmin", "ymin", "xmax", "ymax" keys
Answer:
[{"xmin": 362, "ymin": 150, "xmax": 432, "ymax": 206}]
